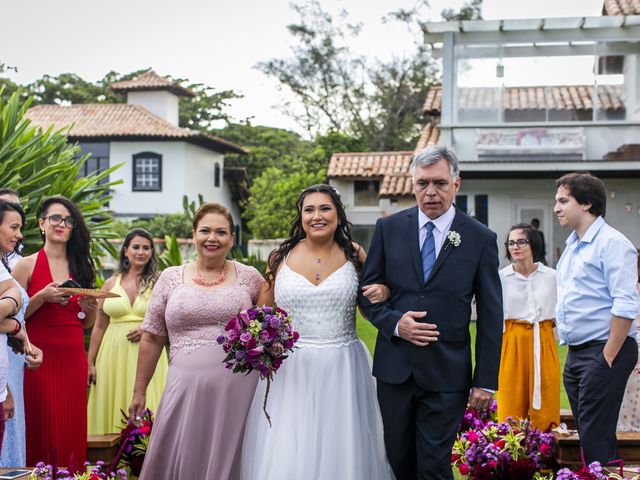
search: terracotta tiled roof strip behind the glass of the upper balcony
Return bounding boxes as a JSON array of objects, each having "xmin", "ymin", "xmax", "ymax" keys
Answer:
[{"xmin": 422, "ymin": 84, "xmax": 624, "ymax": 115}]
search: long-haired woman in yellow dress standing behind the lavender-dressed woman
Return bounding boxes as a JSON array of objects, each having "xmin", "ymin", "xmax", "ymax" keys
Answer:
[{"xmin": 87, "ymin": 228, "xmax": 168, "ymax": 435}]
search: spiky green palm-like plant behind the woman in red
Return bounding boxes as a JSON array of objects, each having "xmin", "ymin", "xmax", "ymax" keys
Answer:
[{"xmin": 0, "ymin": 87, "xmax": 121, "ymax": 259}]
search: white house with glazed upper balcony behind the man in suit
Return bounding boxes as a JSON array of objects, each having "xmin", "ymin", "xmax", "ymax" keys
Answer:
[{"xmin": 328, "ymin": 0, "xmax": 640, "ymax": 264}]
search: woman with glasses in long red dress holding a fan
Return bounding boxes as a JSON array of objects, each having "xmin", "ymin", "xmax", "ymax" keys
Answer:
[{"xmin": 14, "ymin": 197, "xmax": 96, "ymax": 471}]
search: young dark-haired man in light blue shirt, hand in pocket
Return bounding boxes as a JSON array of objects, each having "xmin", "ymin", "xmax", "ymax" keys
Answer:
[{"xmin": 554, "ymin": 173, "xmax": 638, "ymax": 465}]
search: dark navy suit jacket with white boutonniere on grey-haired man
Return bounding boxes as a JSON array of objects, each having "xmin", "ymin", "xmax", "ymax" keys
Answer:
[{"xmin": 359, "ymin": 207, "xmax": 502, "ymax": 392}]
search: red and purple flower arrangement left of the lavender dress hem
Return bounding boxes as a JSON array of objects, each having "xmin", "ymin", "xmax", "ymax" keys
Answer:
[{"xmin": 109, "ymin": 409, "xmax": 153, "ymax": 477}]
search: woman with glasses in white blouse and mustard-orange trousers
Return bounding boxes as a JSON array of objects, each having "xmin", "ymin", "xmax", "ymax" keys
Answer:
[{"xmin": 497, "ymin": 223, "xmax": 560, "ymax": 430}]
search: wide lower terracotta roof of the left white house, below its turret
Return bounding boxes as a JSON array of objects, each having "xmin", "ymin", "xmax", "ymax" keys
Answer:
[{"xmin": 26, "ymin": 103, "xmax": 247, "ymax": 153}]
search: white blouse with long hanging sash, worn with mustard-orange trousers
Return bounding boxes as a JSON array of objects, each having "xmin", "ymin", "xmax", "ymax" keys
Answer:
[{"xmin": 500, "ymin": 262, "xmax": 556, "ymax": 410}]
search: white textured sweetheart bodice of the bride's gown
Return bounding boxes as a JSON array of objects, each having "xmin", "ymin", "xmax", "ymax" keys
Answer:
[{"xmin": 275, "ymin": 262, "xmax": 358, "ymax": 347}]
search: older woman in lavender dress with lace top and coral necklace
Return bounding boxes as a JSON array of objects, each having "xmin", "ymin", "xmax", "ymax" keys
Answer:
[{"xmin": 129, "ymin": 203, "xmax": 263, "ymax": 480}]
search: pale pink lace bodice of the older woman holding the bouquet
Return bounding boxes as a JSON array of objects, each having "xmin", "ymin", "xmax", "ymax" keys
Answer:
[{"xmin": 141, "ymin": 262, "xmax": 264, "ymax": 359}]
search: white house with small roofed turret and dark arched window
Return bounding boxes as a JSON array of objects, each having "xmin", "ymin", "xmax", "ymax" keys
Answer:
[{"xmin": 27, "ymin": 70, "xmax": 247, "ymax": 236}]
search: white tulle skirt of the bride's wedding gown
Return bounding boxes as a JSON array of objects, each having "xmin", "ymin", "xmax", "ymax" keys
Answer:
[{"xmin": 241, "ymin": 341, "xmax": 393, "ymax": 480}]
